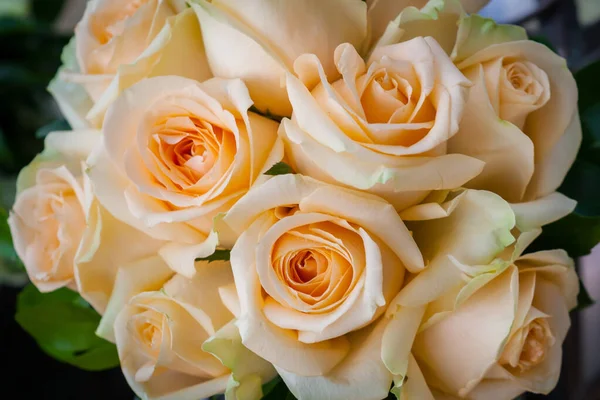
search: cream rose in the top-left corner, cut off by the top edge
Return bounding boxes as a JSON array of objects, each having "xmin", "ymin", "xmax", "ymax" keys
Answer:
[{"xmin": 49, "ymin": 0, "xmax": 211, "ymax": 128}]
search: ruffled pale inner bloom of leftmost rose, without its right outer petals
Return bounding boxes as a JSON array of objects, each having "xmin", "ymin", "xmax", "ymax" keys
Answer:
[{"xmin": 8, "ymin": 130, "xmax": 99, "ymax": 292}]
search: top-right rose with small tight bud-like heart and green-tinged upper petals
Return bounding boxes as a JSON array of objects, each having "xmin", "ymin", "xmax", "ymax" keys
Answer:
[{"xmin": 379, "ymin": 6, "xmax": 581, "ymax": 203}]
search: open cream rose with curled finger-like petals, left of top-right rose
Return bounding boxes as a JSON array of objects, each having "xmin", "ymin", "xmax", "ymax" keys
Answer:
[{"xmin": 280, "ymin": 37, "xmax": 483, "ymax": 209}]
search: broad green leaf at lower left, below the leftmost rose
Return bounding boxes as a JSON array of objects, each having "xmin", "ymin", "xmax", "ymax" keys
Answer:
[{"xmin": 15, "ymin": 284, "xmax": 119, "ymax": 371}]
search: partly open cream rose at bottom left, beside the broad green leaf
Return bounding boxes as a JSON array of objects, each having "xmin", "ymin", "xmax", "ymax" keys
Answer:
[{"xmin": 115, "ymin": 262, "xmax": 275, "ymax": 400}]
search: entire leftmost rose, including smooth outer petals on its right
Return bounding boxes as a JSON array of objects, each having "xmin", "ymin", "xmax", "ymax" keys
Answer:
[{"xmin": 9, "ymin": 131, "xmax": 168, "ymax": 314}]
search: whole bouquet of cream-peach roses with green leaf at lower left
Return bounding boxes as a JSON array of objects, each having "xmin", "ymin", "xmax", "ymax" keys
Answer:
[{"xmin": 9, "ymin": 0, "xmax": 596, "ymax": 400}]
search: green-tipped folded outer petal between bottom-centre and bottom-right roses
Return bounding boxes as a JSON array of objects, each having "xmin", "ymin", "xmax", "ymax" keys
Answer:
[{"xmin": 399, "ymin": 190, "xmax": 516, "ymax": 307}]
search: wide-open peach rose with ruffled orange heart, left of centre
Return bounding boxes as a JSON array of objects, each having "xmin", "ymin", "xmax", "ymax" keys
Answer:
[{"xmin": 89, "ymin": 76, "xmax": 283, "ymax": 276}]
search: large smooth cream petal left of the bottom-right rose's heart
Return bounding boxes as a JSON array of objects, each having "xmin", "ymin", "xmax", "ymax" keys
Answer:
[{"xmin": 413, "ymin": 268, "xmax": 519, "ymax": 396}]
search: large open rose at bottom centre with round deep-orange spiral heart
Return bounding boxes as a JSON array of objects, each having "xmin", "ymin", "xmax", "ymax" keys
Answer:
[{"xmin": 217, "ymin": 174, "xmax": 424, "ymax": 399}]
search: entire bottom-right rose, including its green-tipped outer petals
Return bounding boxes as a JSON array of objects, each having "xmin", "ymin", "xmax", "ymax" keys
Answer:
[{"xmin": 382, "ymin": 190, "xmax": 578, "ymax": 399}]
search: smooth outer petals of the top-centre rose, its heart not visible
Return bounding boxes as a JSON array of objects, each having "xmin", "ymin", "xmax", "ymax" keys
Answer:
[{"xmin": 191, "ymin": 0, "xmax": 367, "ymax": 116}]
